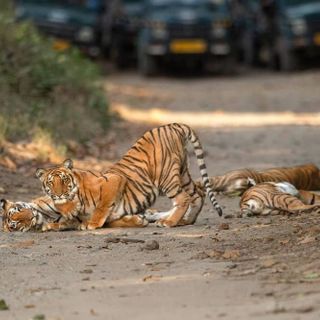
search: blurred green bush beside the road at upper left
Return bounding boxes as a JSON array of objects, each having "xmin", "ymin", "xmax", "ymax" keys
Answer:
[{"xmin": 0, "ymin": 1, "xmax": 110, "ymax": 142}]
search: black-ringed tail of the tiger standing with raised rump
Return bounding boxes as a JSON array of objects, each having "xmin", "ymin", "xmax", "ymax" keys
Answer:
[{"xmin": 180, "ymin": 125, "xmax": 223, "ymax": 217}]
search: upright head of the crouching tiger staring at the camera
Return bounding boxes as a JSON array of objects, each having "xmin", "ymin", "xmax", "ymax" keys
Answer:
[{"xmin": 36, "ymin": 159, "xmax": 78, "ymax": 204}]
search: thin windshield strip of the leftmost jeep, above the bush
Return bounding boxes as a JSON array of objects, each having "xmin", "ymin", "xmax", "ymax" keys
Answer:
[{"xmin": 17, "ymin": 0, "xmax": 104, "ymax": 11}]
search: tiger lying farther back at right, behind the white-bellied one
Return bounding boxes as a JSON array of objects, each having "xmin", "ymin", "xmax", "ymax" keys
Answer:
[{"xmin": 210, "ymin": 164, "xmax": 320, "ymax": 196}]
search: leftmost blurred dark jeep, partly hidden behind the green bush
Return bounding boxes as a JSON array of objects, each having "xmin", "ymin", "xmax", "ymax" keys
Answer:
[{"xmin": 15, "ymin": 0, "xmax": 116, "ymax": 57}]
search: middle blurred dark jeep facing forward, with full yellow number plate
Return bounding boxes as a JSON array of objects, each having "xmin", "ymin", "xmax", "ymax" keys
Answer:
[{"xmin": 138, "ymin": 0, "xmax": 234, "ymax": 75}]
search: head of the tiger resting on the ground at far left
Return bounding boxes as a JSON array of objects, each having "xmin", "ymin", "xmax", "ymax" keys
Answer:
[{"xmin": 0, "ymin": 199, "xmax": 42, "ymax": 232}]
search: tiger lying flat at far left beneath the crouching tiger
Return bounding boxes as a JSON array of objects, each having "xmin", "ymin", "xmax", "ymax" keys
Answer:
[{"xmin": 0, "ymin": 197, "xmax": 148, "ymax": 232}]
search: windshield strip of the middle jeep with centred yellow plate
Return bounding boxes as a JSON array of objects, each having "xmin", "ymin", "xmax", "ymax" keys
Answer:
[{"xmin": 148, "ymin": 0, "xmax": 226, "ymax": 11}]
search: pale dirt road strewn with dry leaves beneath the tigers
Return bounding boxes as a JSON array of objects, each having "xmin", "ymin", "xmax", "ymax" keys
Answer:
[{"xmin": 0, "ymin": 71, "xmax": 320, "ymax": 320}]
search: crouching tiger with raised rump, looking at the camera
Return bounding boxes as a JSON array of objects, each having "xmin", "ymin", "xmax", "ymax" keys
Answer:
[{"xmin": 36, "ymin": 123, "xmax": 222, "ymax": 230}]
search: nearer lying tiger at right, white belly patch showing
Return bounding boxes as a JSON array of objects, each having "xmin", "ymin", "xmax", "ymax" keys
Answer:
[{"xmin": 240, "ymin": 182, "xmax": 320, "ymax": 216}]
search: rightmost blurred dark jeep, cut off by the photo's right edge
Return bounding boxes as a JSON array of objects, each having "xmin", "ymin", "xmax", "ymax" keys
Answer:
[{"xmin": 260, "ymin": 0, "xmax": 320, "ymax": 70}]
